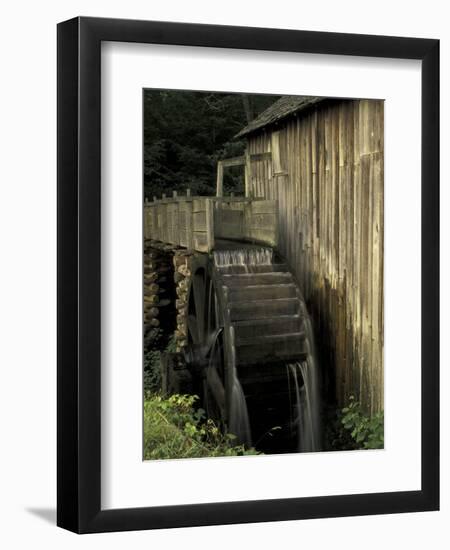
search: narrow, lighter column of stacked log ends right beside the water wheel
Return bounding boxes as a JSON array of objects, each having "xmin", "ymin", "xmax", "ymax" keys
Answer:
[{"xmin": 173, "ymin": 250, "xmax": 192, "ymax": 351}]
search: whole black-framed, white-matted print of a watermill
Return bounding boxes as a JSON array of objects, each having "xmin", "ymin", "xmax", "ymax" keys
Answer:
[{"xmin": 57, "ymin": 17, "xmax": 439, "ymax": 533}]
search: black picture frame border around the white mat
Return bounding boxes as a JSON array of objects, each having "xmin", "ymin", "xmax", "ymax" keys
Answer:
[{"xmin": 57, "ymin": 17, "xmax": 439, "ymax": 533}]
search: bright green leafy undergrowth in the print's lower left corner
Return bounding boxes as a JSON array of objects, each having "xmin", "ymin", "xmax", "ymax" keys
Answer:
[{"xmin": 144, "ymin": 395, "xmax": 258, "ymax": 460}]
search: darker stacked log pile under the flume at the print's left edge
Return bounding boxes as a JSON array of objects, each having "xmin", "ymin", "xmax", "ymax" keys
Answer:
[{"xmin": 144, "ymin": 240, "xmax": 173, "ymax": 331}]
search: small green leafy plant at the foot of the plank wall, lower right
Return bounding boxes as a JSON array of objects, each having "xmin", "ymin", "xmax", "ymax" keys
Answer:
[{"xmin": 341, "ymin": 396, "xmax": 384, "ymax": 449}]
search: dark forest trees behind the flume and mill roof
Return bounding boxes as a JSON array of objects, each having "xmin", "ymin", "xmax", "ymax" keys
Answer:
[{"xmin": 144, "ymin": 90, "xmax": 281, "ymax": 200}]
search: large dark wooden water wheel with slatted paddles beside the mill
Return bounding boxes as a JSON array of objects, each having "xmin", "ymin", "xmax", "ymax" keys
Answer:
[{"xmin": 186, "ymin": 248, "xmax": 312, "ymax": 452}]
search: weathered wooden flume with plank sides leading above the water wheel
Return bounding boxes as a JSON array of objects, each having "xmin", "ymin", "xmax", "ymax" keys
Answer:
[{"xmin": 144, "ymin": 192, "xmax": 278, "ymax": 252}]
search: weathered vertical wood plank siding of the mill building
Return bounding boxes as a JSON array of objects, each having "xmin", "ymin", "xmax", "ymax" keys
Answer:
[{"xmin": 249, "ymin": 100, "xmax": 384, "ymax": 412}]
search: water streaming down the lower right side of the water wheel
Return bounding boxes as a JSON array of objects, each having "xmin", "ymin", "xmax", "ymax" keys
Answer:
[{"xmin": 287, "ymin": 310, "xmax": 320, "ymax": 452}]
